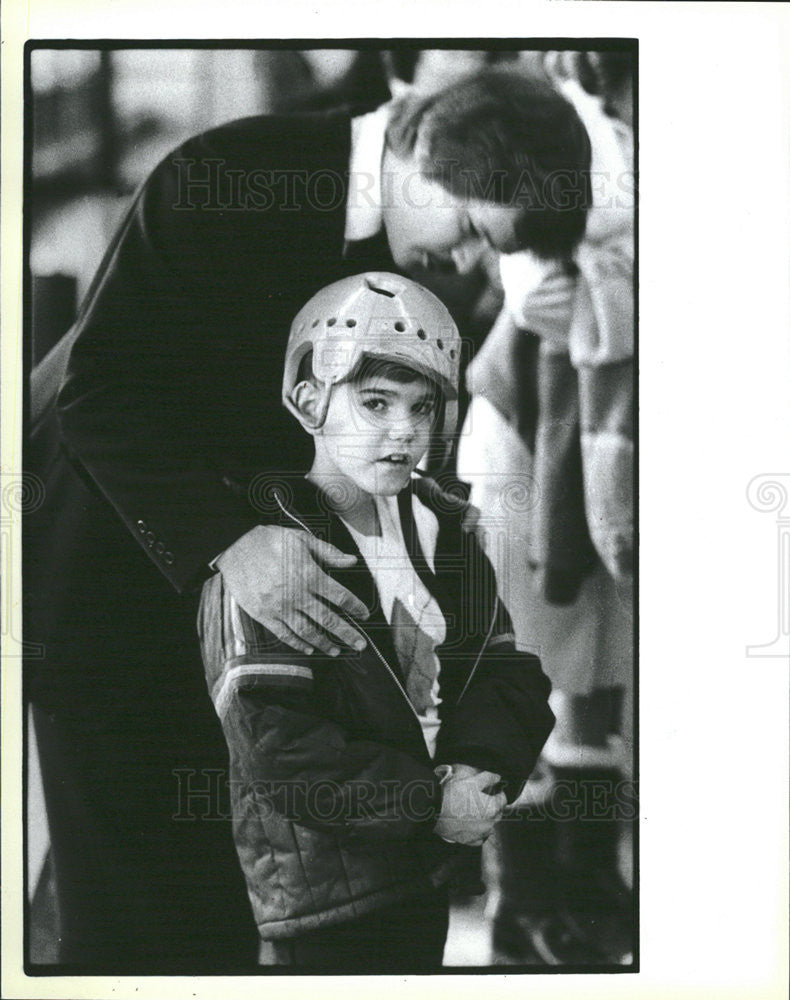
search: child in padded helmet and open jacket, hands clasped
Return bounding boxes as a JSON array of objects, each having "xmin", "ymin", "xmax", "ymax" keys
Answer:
[{"xmin": 199, "ymin": 274, "xmax": 553, "ymax": 972}]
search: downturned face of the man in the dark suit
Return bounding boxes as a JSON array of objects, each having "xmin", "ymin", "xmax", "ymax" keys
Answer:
[{"xmin": 382, "ymin": 150, "xmax": 521, "ymax": 274}]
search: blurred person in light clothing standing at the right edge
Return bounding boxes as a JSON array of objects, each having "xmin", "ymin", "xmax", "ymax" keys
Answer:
[{"xmin": 459, "ymin": 53, "xmax": 634, "ymax": 965}]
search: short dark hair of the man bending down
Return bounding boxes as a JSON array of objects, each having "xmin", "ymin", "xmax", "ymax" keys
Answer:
[{"xmin": 387, "ymin": 69, "xmax": 592, "ymax": 259}]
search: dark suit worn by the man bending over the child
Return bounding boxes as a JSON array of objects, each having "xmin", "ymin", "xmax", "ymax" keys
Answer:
[{"xmin": 25, "ymin": 112, "xmax": 392, "ymax": 968}]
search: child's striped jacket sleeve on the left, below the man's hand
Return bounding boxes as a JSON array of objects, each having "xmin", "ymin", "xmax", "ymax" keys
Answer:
[{"xmin": 199, "ymin": 575, "xmax": 442, "ymax": 842}]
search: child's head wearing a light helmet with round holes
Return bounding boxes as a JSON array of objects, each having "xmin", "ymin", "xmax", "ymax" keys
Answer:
[{"xmin": 283, "ymin": 273, "xmax": 461, "ymax": 495}]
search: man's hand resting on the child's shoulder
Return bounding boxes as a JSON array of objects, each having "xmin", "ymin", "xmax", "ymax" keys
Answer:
[{"xmin": 215, "ymin": 524, "xmax": 368, "ymax": 656}]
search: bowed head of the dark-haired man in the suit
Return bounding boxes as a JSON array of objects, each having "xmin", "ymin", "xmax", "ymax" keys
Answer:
[{"xmin": 382, "ymin": 70, "xmax": 591, "ymax": 272}]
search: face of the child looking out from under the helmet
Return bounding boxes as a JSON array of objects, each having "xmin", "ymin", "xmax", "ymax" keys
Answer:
[{"xmin": 313, "ymin": 374, "xmax": 439, "ymax": 496}]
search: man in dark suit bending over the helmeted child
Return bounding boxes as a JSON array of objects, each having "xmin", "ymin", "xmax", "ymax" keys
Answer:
[{"xmin": 26, "ymin": 73, "xmax": 589, "ymax": 971}]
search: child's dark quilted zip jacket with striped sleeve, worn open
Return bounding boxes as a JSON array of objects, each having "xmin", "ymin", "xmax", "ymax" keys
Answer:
[{"xmin": 199, "ymin": 479, "xmax": 553, "ymax": 939}]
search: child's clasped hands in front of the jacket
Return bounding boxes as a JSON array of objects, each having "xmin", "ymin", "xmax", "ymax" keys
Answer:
[{"xmin": 434, "ymin": 764, "xmax": 507, "ymax": 847}]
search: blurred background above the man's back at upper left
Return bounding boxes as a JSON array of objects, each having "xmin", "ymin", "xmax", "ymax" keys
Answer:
[{"xmin": 28, "ymin": 49, "xmax": 541, "ymax": 363}]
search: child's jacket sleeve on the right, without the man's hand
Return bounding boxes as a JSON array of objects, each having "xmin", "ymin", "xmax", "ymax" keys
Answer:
[{"xmin": 436, "ymin": 599, "xmax": 554, "ymax": 802}]
